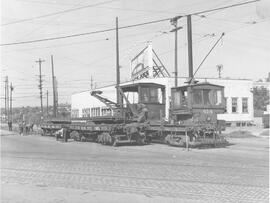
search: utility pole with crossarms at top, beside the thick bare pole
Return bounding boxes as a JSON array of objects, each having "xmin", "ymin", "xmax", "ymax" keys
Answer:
[{"xmin": 170, "ymin": 16, "xmax": 182, "ymax": 87}]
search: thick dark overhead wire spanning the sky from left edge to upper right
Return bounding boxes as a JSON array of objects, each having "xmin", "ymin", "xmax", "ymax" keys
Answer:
[{"xmin": 0, "ymin": 0, "xmax": 260, "ymax": 46}]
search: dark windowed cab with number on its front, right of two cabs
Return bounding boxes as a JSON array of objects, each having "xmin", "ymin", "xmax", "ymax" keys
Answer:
[{"xmin": 171, "ymin": 82, "xmax": 225, "ymax": 120}]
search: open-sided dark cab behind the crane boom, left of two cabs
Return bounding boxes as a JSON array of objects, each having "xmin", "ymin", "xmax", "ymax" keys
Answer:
[{"xmin": 121, "ymin": 83, "xmax": 165, "ymax": 120}]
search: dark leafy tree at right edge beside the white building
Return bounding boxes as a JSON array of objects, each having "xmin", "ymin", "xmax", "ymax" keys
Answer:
[{"xmin": 253, "ymin": 87, "xmax": 269, "ymax": 111}]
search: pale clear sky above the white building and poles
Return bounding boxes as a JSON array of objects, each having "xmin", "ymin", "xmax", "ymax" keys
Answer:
[{"xmin": 0, "ymin": 0, "xmax": 270, "ymax": 107}]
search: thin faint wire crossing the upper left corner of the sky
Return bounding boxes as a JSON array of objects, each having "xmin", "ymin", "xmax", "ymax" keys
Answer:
[{"xmin": 1, "ymin": 0, "xmax": 116, "ymax": 26}]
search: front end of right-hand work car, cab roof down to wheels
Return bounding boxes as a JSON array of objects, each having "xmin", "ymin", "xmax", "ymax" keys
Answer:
[{"xmin": 167, "ymin": 82, "xmax": 227, "ymax": 146}]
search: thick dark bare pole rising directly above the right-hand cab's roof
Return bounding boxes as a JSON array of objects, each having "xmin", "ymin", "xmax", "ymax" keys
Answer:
[{"xmin": 187, "ymin": 15, "xmax": 193, "ymax": 82}]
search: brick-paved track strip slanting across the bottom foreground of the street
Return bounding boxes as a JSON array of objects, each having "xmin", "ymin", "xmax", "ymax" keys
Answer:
[{"xmin": 2, "ymin": 168, "xmax": 268, "ymax": 202}]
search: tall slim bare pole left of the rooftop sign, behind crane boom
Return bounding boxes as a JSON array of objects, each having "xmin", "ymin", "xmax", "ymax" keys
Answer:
[{"xmin": 115, "ymin": 17, "xmax": 122, "ymax": 105}]
